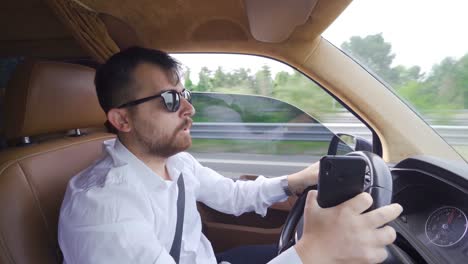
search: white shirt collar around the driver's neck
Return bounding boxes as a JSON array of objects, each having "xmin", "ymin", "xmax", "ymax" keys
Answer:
[{"xmin": 104, "ymin": 139, "xmax": 176, "ymax": 188}]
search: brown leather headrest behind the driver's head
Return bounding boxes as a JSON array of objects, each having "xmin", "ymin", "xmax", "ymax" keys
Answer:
[{"xmin": 4, "ymin": 61, "xmax": 106, "ymax": 139}]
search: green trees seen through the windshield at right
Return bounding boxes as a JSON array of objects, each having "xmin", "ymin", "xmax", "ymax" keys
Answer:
[{"xmin": 341, "ymin": 33, "xmax": 468, "ymax": 124}]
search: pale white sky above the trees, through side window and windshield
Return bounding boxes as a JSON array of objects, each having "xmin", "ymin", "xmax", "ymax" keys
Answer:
[{"xmin": 175, "ymin": 0, "xmax": 468, "ymax": 83}]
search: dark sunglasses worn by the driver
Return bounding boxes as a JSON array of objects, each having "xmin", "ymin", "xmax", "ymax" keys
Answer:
[{"xmin": 117, "ymin": 89, "xmax": 192, "ymax": 112}]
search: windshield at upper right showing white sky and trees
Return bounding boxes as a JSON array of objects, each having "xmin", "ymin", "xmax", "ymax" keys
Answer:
[{"xmin": 323, "ymin": 0, "xmax": 468, "ymax": 160}]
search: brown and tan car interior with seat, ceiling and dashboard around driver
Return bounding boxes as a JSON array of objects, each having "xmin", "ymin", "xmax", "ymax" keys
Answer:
[{"xmin": 0, "ymin": 0, "xmax": 468, "ymax": 263}]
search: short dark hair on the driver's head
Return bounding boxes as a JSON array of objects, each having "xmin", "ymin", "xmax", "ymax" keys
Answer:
[{"xmin": 94, "ymin": 47, "xmax": 180, "ymax": 113}]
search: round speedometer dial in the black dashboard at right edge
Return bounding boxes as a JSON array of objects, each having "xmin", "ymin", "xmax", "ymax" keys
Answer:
[{"xmin": 426, "ymin": 206, "xmax": 468, "ymax": 247}]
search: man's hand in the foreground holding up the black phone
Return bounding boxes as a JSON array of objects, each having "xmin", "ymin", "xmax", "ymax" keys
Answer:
[{"xmin": 295, "ymin": 191, "xmax": 403, "ymax": 264}]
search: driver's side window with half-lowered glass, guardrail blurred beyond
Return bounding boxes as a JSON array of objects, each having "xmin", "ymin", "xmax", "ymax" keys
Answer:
[{"xmin": 174, "ymin": 54, "xmax": 372, "ymax": 178}]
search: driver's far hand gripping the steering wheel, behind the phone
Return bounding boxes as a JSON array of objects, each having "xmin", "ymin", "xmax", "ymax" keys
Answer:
[{"xmin": 288, "ymin": 161, "xmax": 320, "ymax": 194}]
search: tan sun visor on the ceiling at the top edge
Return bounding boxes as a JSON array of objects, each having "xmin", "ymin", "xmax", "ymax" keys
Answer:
[{"xmin": 244, "ymin": 0, "xmax": 318, "ymax": 43}]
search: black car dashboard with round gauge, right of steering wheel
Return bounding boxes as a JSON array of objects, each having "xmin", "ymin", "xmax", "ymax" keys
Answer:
[{"xmin": 391, "ymin": 157, "xmax": 468, "ymax": 263}]
